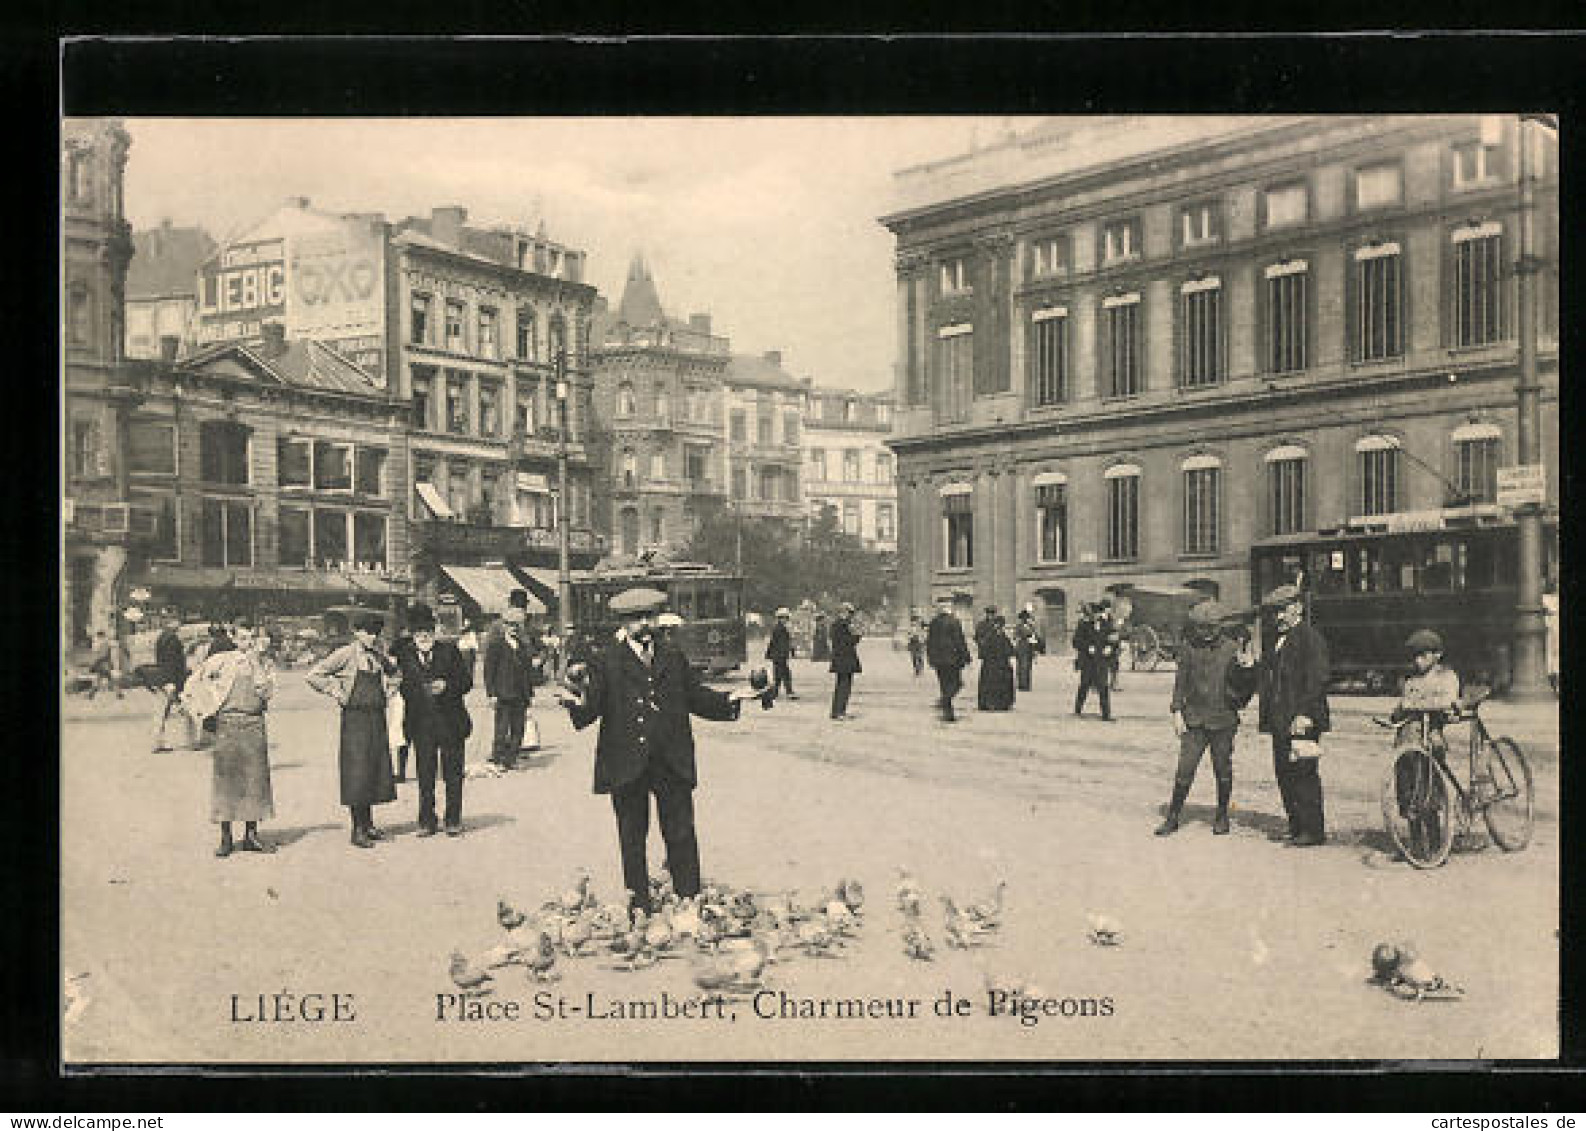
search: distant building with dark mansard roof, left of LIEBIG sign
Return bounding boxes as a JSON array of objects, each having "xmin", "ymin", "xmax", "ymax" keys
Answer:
[{"xmin": 127, "ymin": 220, "xmax": 216, "ymax": 358}]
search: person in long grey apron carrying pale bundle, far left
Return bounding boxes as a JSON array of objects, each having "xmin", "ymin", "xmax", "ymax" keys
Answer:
[{"xmin": 182, "ymin": 620, "xmax": 276, "ymax": 858}]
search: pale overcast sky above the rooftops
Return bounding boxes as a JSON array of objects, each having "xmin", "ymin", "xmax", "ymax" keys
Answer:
[{"xmin": 127, "ymin": 117, "xmax": 1029, "ymax": 390}]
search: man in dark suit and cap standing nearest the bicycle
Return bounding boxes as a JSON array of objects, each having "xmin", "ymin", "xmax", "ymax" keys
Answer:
[{"xmin": 1259, "ymin": 585, "xmax": 1332, "ymax": 847}]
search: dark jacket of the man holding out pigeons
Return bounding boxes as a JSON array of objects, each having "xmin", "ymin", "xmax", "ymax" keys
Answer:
[{"xmin": 568, "ymin": 639, "xmax": 737, "ymax": 793}]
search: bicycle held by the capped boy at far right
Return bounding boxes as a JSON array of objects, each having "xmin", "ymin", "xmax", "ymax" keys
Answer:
[{"xmin": 1372, "ymin": 700, "xmax": 1535, "ymax": 868}]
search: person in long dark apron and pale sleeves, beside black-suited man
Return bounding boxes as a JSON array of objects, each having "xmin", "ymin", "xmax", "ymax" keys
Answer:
[{"xmin": 306, "ymin": 615, "xmax": 397, "ymax": 849}]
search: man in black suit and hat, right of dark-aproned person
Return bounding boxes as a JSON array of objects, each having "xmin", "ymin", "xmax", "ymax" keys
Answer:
[{"xmin": 392, "ymin": 604, "xmax": 474, "ymax": 836}]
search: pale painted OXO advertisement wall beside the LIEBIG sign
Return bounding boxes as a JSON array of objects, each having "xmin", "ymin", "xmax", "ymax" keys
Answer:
[{"xmin": 287, "ymin": 220, "xmax": 385, "ymax": 385}]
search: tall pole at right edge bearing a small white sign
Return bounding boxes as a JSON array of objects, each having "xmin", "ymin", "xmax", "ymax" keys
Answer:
[{"xmin": 1510, "ymin": 114, "xmax": 1553, "ymax": 701}]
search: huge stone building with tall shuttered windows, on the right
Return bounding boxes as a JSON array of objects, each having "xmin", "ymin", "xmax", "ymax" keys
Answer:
[{"xmin": 882, "ymin": 116, "xmax": 1557, "ymax": 639}]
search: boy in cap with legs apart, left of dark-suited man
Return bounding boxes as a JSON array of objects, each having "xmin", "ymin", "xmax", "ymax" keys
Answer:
[{"xmin": 1156, "ymin": 601, "xmax": 1256, "ymax": 836}]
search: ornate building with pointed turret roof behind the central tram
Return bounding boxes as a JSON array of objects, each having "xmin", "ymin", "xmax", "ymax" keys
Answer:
[{"xmin": 592, "ymin": 255, "xmax": 731, "ymax": 557}]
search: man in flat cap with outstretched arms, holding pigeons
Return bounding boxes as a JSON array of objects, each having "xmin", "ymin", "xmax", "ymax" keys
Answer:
[{"xmin": 557, "ymin": 587, "xmax": 761, "ymax": 909}]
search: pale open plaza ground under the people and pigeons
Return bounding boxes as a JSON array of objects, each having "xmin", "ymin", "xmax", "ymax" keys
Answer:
[{"xmin": 60, "ymin": 644, "xmax": 1559, "ymax": 1063}]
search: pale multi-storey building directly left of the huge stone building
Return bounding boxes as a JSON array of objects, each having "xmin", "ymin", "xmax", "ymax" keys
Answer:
[{"xmin": 804, "ymin": 387, "xmax": 898, "ymax": 552}]
